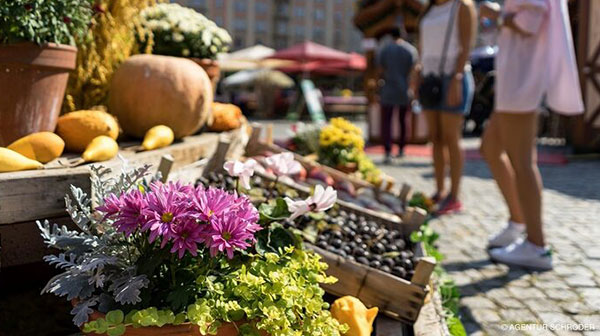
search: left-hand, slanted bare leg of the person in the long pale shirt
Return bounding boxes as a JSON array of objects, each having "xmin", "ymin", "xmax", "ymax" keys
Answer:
[{"xmin": 479, "ymin": 113, "xmax": 525, "ymax": 223}]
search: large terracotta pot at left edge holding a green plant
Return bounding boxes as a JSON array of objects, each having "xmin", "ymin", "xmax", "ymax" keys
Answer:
[{"xmin": 0, "ymin": 43, "xmax": 77, "ymax": 146}]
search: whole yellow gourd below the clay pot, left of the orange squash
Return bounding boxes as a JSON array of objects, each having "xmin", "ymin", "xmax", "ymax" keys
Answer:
[{"xmin": 7, "ymin": 132, "xmax": 65, "ymax": 163}]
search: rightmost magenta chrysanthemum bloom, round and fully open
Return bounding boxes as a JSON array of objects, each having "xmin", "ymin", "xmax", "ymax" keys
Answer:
[{"xmin": 204, "ymin": 212, "xmax": 254, "ymax": 259}]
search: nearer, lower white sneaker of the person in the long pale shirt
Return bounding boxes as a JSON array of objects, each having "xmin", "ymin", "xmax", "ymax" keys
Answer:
[{"xmin": 490, "ymin": 239, "xmax": 552, "ymax": 271}]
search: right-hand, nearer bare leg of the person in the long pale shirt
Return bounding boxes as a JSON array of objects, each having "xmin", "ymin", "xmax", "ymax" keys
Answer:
[{"xmin": 498, "ymin": 112, "xmax": 545, "ymax": 246}]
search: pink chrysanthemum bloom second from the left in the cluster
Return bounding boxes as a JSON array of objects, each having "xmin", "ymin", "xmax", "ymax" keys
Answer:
[{"xmin": 142, "ymin": 183, "xmax": 191, "ymax": 243}]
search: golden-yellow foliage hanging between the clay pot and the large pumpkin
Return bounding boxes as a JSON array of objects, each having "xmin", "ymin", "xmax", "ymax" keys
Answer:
[{"xmin": 63, "ymin": 0, "xmax": 161, "ymax": 111}]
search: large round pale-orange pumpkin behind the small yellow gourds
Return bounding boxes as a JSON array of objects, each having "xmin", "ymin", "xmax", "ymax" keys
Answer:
[{"xmin": 109, "ymin": 55, "xmax": 213, "ymax": 138}]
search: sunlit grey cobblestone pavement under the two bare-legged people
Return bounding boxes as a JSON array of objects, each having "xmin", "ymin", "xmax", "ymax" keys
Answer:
[{"xmin": 375, "ymin": 140, "xmax": 600, "ymax": 336}]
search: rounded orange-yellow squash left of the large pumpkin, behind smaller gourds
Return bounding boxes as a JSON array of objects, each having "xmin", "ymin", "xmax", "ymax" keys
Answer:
[{"xmin": 56, "ymin": 110, "xmax": 119, "ymax": 153}]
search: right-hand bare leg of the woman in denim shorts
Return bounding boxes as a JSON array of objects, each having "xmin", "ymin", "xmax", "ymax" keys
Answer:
[{"xmin": 440, "ymin": 112, "xmax": 464, "ymax": 200}]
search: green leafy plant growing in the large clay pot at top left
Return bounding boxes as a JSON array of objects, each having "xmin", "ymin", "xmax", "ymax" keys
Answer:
[{"xmin": 0, "ymin": 0, "xmax": 94, "ymax": 45}]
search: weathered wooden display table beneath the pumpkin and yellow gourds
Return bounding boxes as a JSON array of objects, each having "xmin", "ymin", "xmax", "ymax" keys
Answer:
[{"xmin": 0, "ymin": 128, "xmax": 248, "ymax": 268}]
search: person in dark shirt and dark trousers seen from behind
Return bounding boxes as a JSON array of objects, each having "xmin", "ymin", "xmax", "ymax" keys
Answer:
[{"xmin": 377, "ymin": 28, "xmax": 418, "ymax": 164}]
